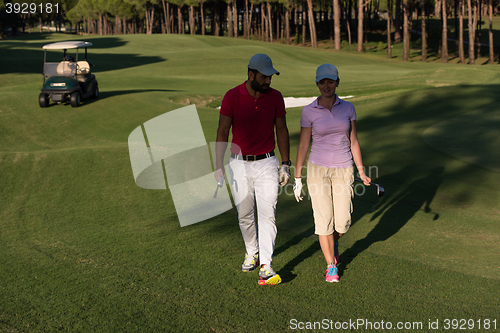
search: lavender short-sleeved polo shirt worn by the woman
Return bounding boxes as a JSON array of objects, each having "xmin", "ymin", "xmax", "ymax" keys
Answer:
[{"xmin": 300, "ymin": 96, "xmax": 356, "ymax": 168}]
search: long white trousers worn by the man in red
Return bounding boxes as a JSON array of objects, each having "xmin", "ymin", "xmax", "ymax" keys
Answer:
[{"xmin": 229, "ymin": 156, "xmax": 279, "ymax": 265}]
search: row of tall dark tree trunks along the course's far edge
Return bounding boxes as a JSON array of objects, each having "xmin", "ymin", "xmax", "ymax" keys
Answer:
[{"xmin": 0, "ymin": 0, "xmax": 499, "ymax": 64}]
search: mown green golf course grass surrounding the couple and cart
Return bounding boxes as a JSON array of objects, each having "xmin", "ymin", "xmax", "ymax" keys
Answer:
[{"xmin": 0, "ymin": 34, "xmax": 500, "ymax": 333}]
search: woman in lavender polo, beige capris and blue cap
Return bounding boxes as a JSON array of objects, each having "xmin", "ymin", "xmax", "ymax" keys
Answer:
[{"xmin": 293, "ymin": 64, "xmax": 371, "ymax": 282}]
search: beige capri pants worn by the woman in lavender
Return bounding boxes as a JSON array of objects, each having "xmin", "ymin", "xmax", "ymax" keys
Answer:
[{"xmin": 307, "ymin": 162, "xmax": 354, "ymax": 236}]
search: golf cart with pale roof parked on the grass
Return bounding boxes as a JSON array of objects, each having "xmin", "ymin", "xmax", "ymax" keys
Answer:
[{"xmin": 38, "ymin": 41, "xmax": 99, "ymax": 108}]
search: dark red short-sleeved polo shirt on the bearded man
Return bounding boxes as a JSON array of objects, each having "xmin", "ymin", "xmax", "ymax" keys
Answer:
[{"xmin": 220, "ymin": 81, "xmax": 286, "ymax": 155}]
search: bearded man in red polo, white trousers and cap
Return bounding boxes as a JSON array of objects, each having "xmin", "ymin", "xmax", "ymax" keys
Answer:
[{"xmin": 215, "ymin": 54, "xmax": 291, "ymax": 285}]
